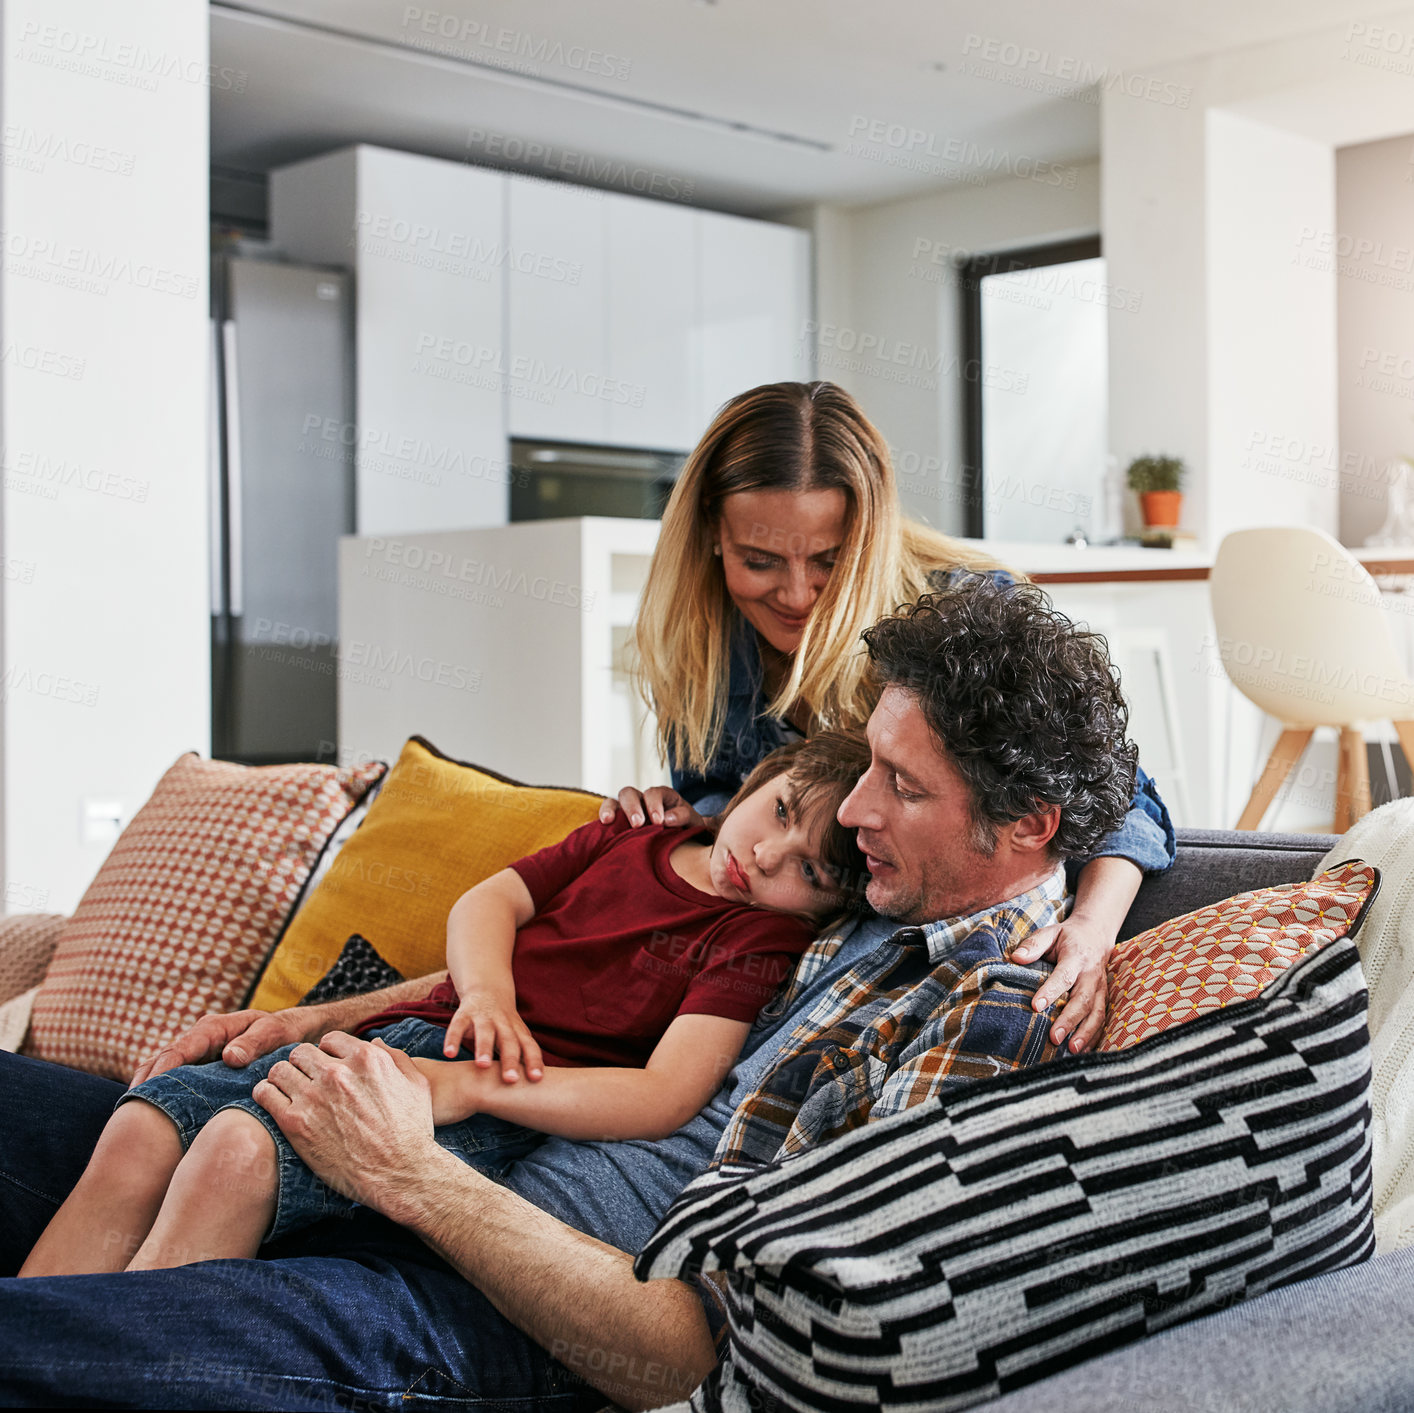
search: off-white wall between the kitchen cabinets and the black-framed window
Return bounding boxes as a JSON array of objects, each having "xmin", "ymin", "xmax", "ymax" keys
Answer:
[{"xmin": 814, "ymin": 163, "xmax": 1100, "ymax": 533}]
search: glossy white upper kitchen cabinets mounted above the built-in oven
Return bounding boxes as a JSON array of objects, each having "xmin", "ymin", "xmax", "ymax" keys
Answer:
[{"xmin": 506, "ymin": 177, "xmax": 812, "ymax": 451}]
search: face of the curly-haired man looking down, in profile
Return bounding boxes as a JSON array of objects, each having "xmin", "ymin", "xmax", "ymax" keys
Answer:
[{"xmin": 839, "ymin": 687, "xmax": 1051, "ymax": 922}]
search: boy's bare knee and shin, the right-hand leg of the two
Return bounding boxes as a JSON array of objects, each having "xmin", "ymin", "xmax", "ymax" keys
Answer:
[{"xmin": 127, "ymin": 1109, "xmax": 276, "ymax": 1270}]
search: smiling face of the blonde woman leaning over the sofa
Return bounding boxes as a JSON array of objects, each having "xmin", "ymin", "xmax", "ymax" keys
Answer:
[{"xmin": 717, "ymin": 488, "xmax": 848, "ymax": 655}]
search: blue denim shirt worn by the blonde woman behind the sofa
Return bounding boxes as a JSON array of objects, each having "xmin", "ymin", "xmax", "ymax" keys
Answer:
[{"xmin": 673, "ymin": 594, "xmax": 1175, "ymax": 873}]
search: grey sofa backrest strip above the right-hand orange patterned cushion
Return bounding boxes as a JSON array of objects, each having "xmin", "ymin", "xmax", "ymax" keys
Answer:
[{"xmin": 1120, "ymin": 829, "xmax": 1339, "ymax": 942}]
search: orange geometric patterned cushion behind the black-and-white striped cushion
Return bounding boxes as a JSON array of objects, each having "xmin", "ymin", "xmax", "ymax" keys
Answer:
[{"xmin": 1096, "ymin": 860, "xmax": 1380, "ymax": 1049}]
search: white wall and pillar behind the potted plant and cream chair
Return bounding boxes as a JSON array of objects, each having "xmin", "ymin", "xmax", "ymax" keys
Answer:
[{"xmin": 1102, "ymin": 8, "xmax": 1414, "ymax": 547}]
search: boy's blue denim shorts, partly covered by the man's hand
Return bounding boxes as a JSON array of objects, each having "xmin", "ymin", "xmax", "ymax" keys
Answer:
[{"xmin": 115, "ymin": 1018, "xmax": 544, "ymax": 1242}]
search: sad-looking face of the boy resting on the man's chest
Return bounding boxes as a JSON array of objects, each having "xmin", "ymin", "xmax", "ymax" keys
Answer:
[{"xmin": 708, "ymin": 775, "xmax": 840, "ymax": 921}]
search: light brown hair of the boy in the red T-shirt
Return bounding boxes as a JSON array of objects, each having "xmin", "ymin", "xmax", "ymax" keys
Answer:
[{"xmin": 721, "ymin": 730, "xmax": 870, "ymax": 912}]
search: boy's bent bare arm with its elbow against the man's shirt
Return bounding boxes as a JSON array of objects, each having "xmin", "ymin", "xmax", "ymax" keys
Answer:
[{"xmin": 443, "ymin": 1016, "xmax": 751, "ymax": 1139}]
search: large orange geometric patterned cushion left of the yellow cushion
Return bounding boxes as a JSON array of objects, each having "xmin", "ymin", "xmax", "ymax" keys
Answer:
[{"xmin": 24, "ymin": 755, "xmax": 386, "ymax": 1082}]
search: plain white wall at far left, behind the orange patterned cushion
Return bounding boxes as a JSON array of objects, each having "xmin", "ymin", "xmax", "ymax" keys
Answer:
[{"xmin": 0, "ymin": 0, "xmax": 209, "ymax": 911}]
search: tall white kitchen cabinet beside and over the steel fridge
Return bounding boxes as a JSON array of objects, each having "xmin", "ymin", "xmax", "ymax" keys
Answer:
[{"xmin": 270, "ymin": 146, "xmax": 509, "ymax": 535}]
